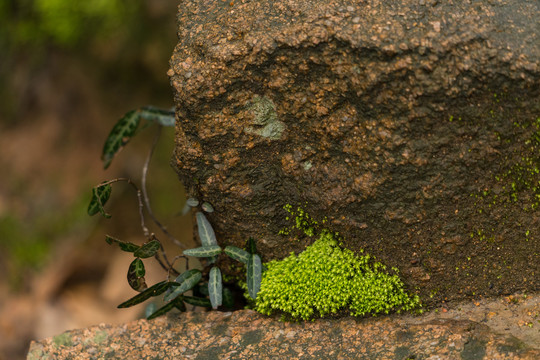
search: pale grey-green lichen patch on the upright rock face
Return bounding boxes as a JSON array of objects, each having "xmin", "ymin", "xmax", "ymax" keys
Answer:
[{"xmin": 244, "ymin": 96, "xmax": 285, "ymax": 140}]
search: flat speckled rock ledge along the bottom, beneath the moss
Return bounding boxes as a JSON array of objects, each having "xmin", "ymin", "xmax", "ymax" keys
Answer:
[{"xmin": 27, "ymin": 310, "xmax": 540, "ymax": 360}]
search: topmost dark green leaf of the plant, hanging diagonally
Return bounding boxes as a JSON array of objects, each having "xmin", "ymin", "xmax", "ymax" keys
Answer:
[{"xmin": 101, "ymin": 110, "xmax": 140, "ymax": 169}]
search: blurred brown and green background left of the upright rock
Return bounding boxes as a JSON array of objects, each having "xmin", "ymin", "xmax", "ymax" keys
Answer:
[{"xmin": 0, "ymin": 0, "xmax": 192, "ymax": 360}]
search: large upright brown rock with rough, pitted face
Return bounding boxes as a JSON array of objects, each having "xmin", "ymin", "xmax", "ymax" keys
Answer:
[{"xmin": 169, "ymin": 0, "xmax": 540, "ymax": 303}]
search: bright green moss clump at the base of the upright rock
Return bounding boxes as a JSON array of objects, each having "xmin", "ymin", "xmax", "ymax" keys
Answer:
[{"xmin": 255, "ymin": 230, "xmax": 420, "ymax": 320}]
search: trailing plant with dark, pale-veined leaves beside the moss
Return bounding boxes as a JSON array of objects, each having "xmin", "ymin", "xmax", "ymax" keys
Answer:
[{"xmin": 88, "ymin": 107, "xmax": 263, "ymax": 319}]
